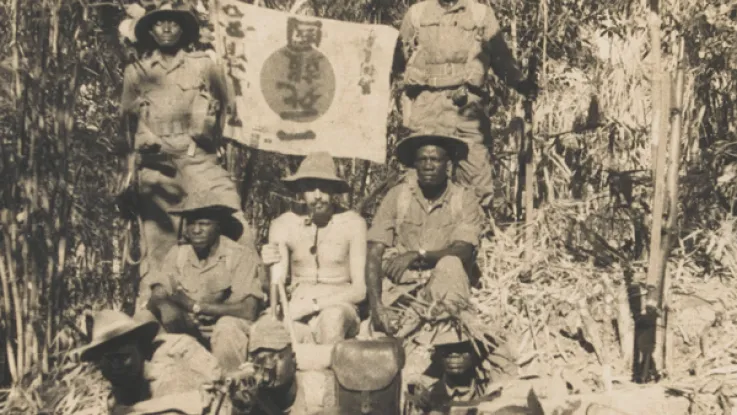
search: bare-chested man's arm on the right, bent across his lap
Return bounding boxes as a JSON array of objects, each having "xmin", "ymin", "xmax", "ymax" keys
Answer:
[{"xmin": 317, "ymin": 214, "xmax": 366, "ymax": 310}]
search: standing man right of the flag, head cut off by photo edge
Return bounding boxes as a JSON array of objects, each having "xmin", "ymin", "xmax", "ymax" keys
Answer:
[{"xmin": 400, "ymin": 0, "xmax": 537, "ymax": 207}]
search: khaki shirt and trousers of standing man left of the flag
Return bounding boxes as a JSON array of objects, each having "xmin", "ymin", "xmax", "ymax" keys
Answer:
[{"xmin": 121, "ymin": 50, "xmax": 254, "ymax": 296}]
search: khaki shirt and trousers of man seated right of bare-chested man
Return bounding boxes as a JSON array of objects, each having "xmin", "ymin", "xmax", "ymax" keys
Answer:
[{"xmin": 368, "ymin": 181, "xmax": 484, "ymax": 301}]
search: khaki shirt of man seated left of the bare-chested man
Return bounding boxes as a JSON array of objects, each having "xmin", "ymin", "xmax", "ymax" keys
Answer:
[{"xmin": 151, "ymin": 236, "xmax": 264, "ymax": 304}]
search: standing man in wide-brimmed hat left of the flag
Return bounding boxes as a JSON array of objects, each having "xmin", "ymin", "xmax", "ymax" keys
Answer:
[{"xmin": 121, "ymin": 0, "xmax": 255, "ymax": 304}]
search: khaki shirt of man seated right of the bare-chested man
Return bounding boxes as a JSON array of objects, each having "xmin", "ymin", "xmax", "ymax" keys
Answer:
[{"xmin": 368, "ymin": 181, "xmax": 484, "ymax": 252}]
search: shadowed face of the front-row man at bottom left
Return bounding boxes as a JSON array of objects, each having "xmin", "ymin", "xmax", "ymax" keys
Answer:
[{"xmin": 99, "ymin": 341, "xmax": 144, "ymax": 387}]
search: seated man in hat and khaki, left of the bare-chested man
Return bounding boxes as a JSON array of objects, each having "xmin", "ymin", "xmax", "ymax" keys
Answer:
[{"xmin": 148, "ymin": 192, "xmax": 264, "ymax": 371}]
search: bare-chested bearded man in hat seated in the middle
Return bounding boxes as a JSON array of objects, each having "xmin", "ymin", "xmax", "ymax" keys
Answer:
[{"xmin": 262, "ymin": 152, "xmax": 366, "ymax": 344}]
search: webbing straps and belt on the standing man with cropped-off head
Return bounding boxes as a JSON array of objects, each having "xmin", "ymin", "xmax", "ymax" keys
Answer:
[{"xmin": 405, "ymin": 0, "xmax": 487, "ymax": 88}]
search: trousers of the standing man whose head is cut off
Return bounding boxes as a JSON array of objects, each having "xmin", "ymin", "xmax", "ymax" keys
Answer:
[{"xmin": 403, "ymin": 89, "xmax": 494, "ymax": 200}]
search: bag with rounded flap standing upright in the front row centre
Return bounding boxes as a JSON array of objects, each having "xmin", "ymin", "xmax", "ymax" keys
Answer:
[{"xmin": 331, "ymin": 337, "xmax": 404, "ymax": 415}]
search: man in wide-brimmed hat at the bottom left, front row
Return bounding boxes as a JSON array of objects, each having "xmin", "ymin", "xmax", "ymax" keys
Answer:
[{"xmin": 78, "ymin": 310, "xmax": 221, "ymax": 414}]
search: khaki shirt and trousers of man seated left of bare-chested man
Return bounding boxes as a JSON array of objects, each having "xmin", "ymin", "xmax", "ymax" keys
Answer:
[{"xmin": 151, "ymin": 236, "xmax": 264, "ymax": 370}]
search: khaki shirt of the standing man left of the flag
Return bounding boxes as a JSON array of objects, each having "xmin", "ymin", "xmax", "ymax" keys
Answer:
[{"xmin": 120, "ymin": 50, "xmax": 228, "ymax": 153}]
